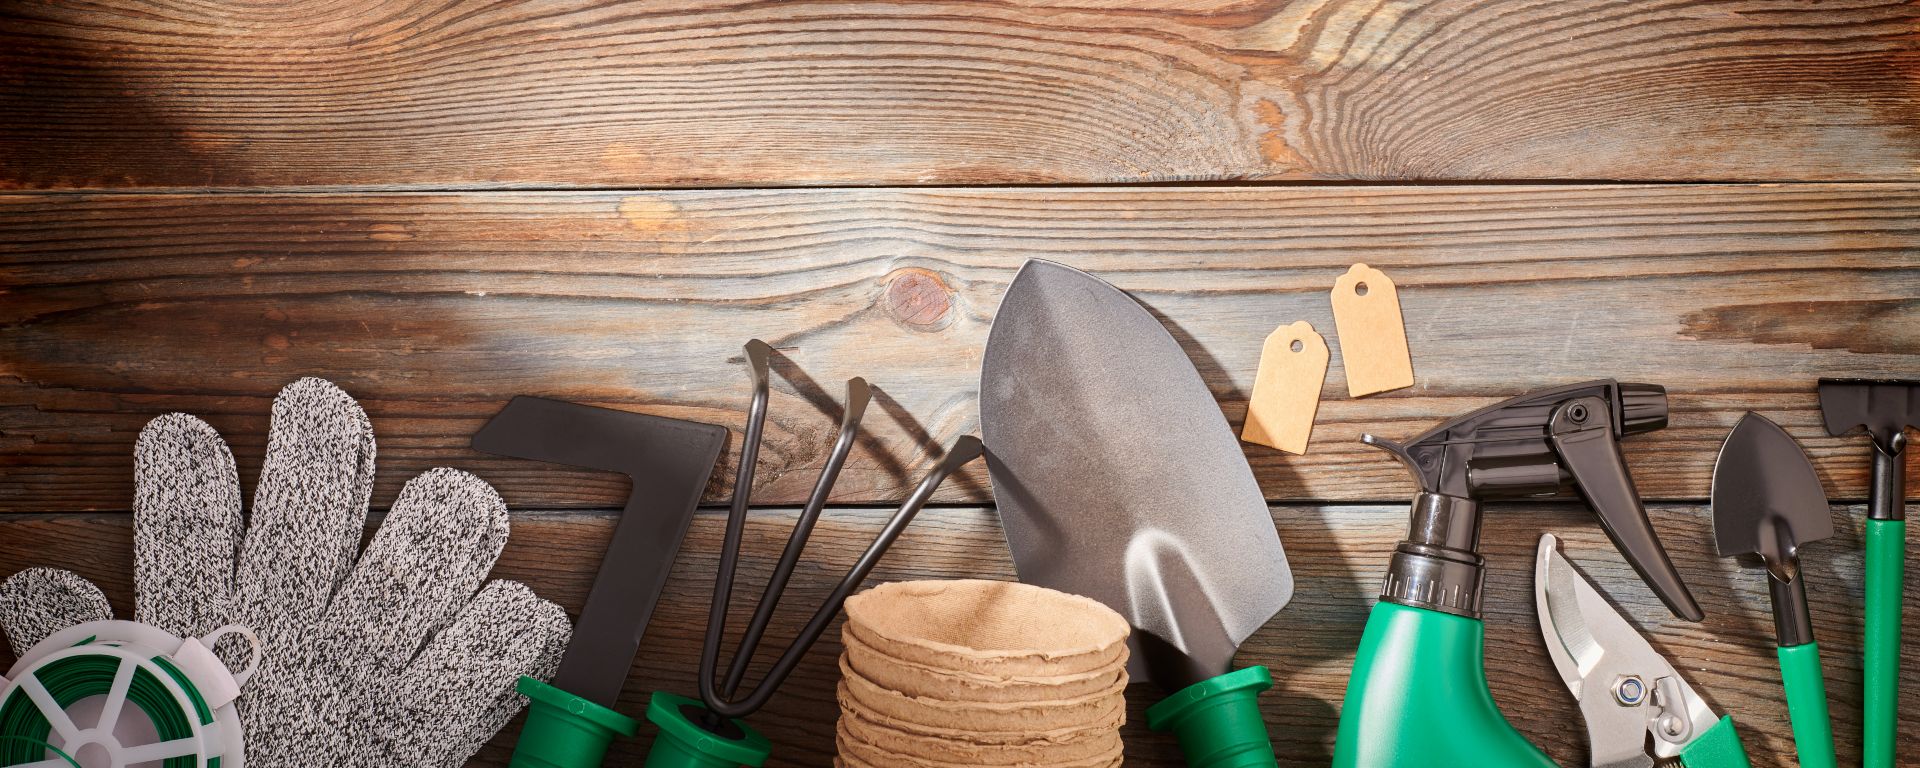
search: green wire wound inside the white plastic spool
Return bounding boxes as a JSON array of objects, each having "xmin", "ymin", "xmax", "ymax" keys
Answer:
[{"xmin": 0, "ymin": 653, "xmax": 219, "ymax": 768}]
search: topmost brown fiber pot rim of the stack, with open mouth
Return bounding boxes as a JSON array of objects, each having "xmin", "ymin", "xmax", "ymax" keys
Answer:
[{"xmin": 845, "ymin": 580, "xmax": 1129, "ymax": 676}]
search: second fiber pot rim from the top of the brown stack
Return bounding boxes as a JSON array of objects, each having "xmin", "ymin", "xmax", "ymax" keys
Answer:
[{"xmin": 841, "ymin": 632, "xmax": 1127, "ymax": 703}]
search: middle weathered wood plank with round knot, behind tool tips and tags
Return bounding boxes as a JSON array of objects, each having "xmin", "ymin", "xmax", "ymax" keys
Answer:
[{"xmin": 0, "ymin": 184, "xmax": 1920, "ymax": 511}]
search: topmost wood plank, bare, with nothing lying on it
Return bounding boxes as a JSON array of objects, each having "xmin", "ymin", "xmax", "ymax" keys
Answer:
[{"xmin": 0, "ymin": 0, "xmax": 1920, "ymax": 188}]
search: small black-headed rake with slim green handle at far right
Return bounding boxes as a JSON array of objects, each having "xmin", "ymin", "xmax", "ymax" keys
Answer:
[{"xmin": 1820, "ymin": 378, "xmax": 1920, "ymax": 768}]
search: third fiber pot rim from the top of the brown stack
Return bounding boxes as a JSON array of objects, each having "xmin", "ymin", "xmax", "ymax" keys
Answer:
[{"xmin": 841, "ymin": 660, "xmax": 1127, "ymax": 732}]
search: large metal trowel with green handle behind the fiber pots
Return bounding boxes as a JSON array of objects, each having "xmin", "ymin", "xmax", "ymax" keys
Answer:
[{"xmin": 979, "ymin": 261, "xmax": 1294, "ymax": 768}]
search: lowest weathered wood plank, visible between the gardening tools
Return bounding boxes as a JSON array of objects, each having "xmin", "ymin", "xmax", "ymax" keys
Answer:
[{"xmin": 0, "ymin": 505, "xmax": 1920, "ymax": 766}]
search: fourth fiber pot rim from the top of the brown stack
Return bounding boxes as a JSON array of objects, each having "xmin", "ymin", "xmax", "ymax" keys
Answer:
[{"xmin": 837, "ymin": 712, "xmax": 1119, "ymax": 766}]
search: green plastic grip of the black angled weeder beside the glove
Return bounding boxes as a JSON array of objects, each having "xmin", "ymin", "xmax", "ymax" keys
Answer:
[{"xmin": 509, "ymin": 678, "xmax": 639, "ymax": 768}]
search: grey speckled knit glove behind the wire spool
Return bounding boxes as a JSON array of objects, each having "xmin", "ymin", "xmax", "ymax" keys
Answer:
[{"xmin": 0, "ymin": 378, "xmax": 572, "ymax": 768}]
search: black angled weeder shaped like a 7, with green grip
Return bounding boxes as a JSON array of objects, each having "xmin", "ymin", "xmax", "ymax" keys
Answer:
[{"xmin": 472, "ymin": 396, "xmax": 726, "ymax": 768}]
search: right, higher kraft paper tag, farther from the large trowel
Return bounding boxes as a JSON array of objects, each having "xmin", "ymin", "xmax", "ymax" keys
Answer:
[{"xmin": 1332, "ymin": 263, "xmax": 1413, "ymax": 397}]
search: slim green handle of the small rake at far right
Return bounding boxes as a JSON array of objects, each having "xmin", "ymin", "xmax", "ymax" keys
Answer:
[{"xmin": 1860, "ymin": 520, "xmax": 1907, "ymax": 768}]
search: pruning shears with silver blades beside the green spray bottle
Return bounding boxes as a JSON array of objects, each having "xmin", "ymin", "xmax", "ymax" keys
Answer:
[{"xmin": 1534, "ymin": 534, "xmax": 1747, "ymax": 768}]
